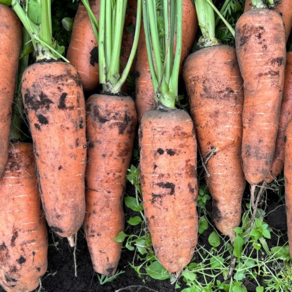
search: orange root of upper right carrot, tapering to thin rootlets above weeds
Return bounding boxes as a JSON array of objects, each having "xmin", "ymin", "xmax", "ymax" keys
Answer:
[{"xmin": 235, "ymin": 9, "xmax": 286, "ymax": 184}]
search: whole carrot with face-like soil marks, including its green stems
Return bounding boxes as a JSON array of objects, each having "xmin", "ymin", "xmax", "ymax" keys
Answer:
[{"xmin": 139, "ymin": 0, "xmax": 198, "ymax": 276}]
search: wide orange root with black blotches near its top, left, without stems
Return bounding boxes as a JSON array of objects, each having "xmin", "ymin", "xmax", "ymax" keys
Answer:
[{"xmin": 22, "ymin": 62, "xmax": 87, "ymax": 237}]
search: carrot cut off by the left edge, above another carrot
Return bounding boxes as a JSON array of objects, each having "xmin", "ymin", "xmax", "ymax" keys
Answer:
[{"xmin": 0, "ymin": 4, "xmax": 22, "ymax": 177}]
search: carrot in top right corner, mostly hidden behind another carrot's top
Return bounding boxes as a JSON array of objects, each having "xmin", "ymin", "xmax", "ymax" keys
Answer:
[{"xmin": 244, "ymin": 0, "xmax": 292, "ymax": 42}]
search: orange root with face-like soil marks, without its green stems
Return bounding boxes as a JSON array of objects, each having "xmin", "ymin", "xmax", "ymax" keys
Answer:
[{"xmin": 139, "ymin": 110, "xmax": 198, "ymax": 274}]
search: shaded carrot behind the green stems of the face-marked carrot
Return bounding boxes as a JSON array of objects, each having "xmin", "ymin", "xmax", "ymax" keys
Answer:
[{"xmin": 135, "ymin": 0, "xmax": 198, "ymax": 123}]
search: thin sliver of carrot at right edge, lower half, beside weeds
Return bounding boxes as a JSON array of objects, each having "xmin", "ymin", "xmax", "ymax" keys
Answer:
[{"xmin": 284, "ymin": 121, "xmax": 292, "ymax": 256}]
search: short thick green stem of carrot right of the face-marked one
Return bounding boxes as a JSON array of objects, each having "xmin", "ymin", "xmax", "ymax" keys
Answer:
[{"xmin": 195, "ymin": 0, "xmax": 219, "ymax": 47}]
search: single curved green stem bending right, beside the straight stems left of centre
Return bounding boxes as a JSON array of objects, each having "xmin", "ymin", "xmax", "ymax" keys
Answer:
[{"xmin": 112, "ymin": 0, "xmax": 142, "ymax": 93}]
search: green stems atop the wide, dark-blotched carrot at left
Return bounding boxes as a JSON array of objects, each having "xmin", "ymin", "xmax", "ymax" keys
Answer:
[{"xmin": 11, "ymin": 0, "xmax": 68, "ymax": 62}]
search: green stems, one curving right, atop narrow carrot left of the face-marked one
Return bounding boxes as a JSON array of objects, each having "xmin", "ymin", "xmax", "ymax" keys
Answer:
[{"xmin": 82, "ymin": 0, "xmax": 142, "ymax": 94}]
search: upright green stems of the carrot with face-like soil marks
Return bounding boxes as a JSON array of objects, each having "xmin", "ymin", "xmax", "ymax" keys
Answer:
[{"xmin": 143, "ymin": 0, "xmax": 182, "ymax": 108}]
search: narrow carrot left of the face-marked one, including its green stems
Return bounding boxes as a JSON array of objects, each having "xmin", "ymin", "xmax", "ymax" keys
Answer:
[{"xmin": 84, "ymin": 0, "xmax": 142, "ymax": 276}]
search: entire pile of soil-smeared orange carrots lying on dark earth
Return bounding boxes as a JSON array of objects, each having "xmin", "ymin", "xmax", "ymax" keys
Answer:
[{"xmin": 0, "ymin": 0, "xmax": 292, "ymax": 292}]
